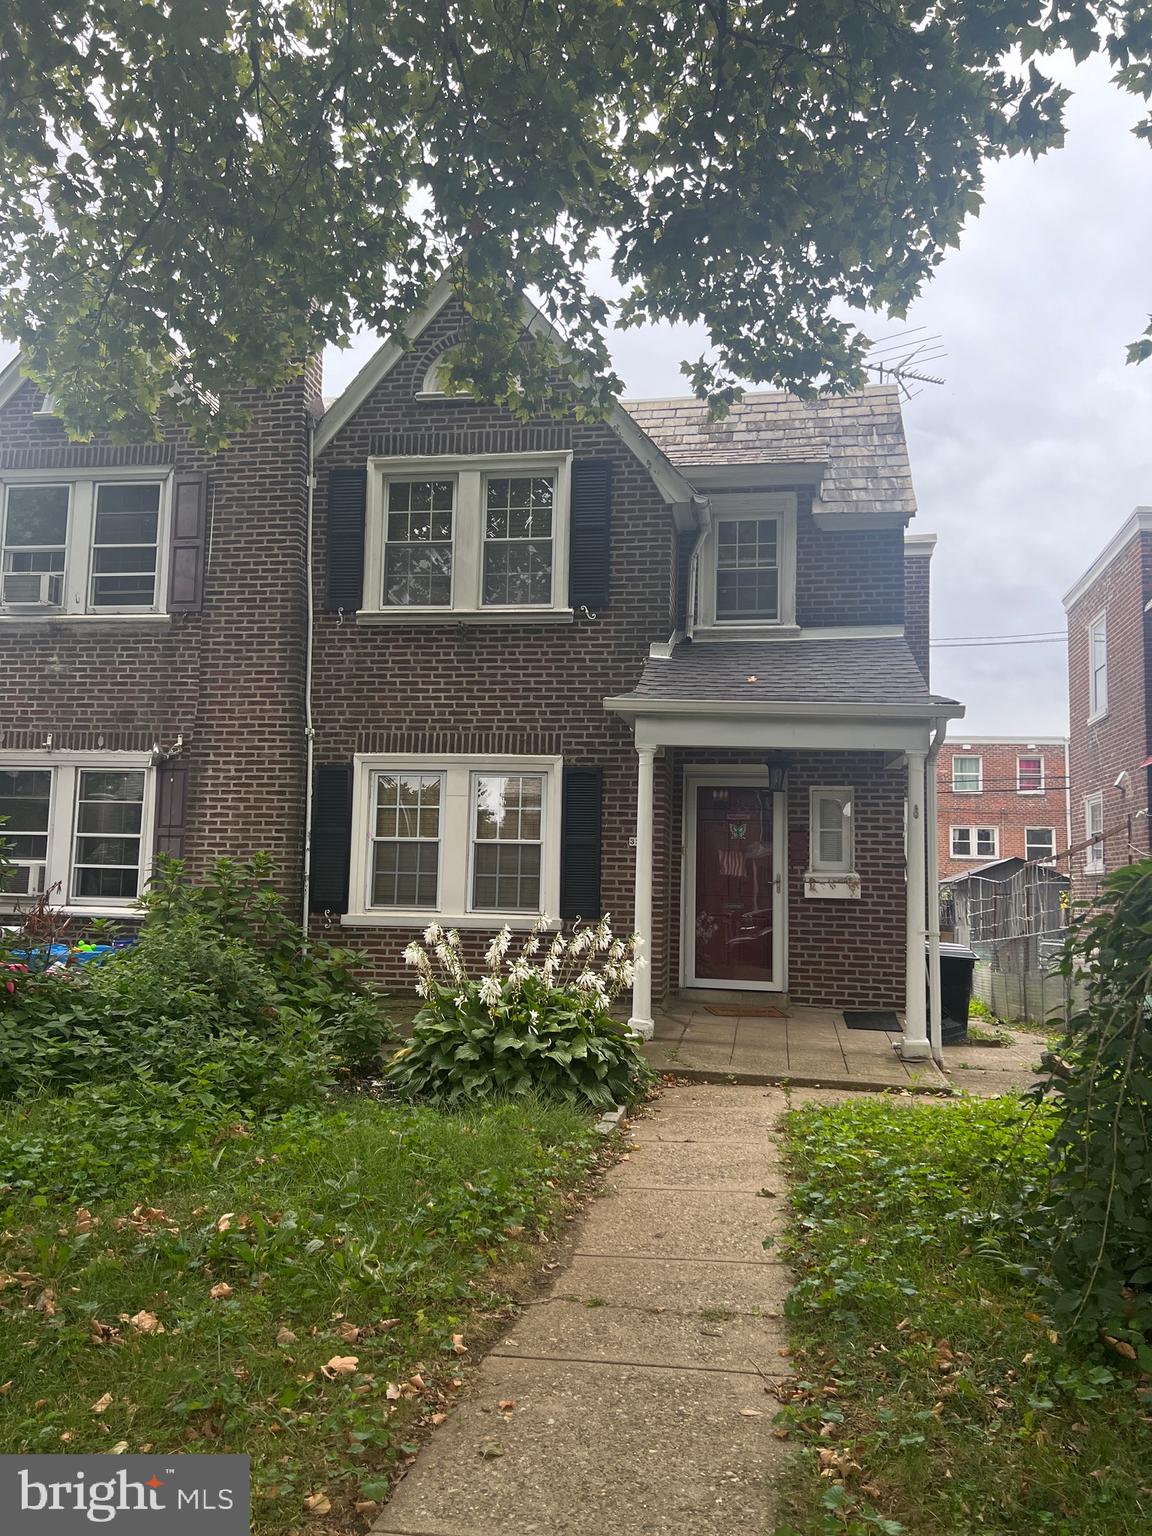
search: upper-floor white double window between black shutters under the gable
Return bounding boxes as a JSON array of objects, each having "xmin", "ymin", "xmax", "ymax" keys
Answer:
[{"xmin": 361, "ymin": 453, "xmax": 571, "ymax": 619}]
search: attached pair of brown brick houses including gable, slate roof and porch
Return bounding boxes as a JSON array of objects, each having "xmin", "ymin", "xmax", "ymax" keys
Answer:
[{"xmin": 0, "ymin": 286, "xmax": 963, "ymax": 1055}]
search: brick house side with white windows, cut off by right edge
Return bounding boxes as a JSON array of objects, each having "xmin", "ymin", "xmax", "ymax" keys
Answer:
[{"xmin": 1064, "ymin": 507, "xmax": 1152, "ymax": 895}]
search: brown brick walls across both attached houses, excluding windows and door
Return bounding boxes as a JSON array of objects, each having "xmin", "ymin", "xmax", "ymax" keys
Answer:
[{"xmin": 0, "ymin": 297, "xmax": 928, "ymax": 1008}]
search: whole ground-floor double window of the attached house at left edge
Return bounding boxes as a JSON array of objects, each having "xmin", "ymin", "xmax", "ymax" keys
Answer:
[{"xmin": 0, "ymin": 753, "xmax": 152, "ymax": 912}]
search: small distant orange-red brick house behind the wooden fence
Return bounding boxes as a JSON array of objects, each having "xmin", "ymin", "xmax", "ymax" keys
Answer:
[{"xmin": 935, "ymin": 736, "xmax": 1069, "ymax": 876}]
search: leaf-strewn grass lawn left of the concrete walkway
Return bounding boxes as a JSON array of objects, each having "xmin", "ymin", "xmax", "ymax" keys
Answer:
[{"xmin": 0, "ymin": 1098, "xmax": 602, "ymax": 1533}]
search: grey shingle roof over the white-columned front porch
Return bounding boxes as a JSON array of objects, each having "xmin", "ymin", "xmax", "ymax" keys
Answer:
[{"xmin": 630, "ymin": 637, "xmax": 951, "ymax": 705}]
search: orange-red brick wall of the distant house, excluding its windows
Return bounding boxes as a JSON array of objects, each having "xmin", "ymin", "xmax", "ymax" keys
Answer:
[{"xmin": 935, "ymin": 740, "xmax": 1075, "ymax": 876}]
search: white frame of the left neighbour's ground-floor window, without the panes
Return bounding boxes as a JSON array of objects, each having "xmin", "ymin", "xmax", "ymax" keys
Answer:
[{"xmin": 0, "ymin": 751, "xmax": 157, "ymax": 917}]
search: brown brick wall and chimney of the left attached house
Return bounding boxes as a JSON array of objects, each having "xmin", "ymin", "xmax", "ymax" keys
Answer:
[{"xmin": 0, "ymin": 369, "xmax": 319, "ymax": 899}]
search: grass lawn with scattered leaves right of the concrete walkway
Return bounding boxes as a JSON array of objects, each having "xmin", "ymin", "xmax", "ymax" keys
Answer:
[{"xmin": 777, "ymin": 1098, "xmax": 1152, "ymax": 1536}]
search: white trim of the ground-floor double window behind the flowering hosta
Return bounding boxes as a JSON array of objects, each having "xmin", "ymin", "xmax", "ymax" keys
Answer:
[{"xmin": 341, "ymin": 753, "xmax": 564, "ymax": 929}]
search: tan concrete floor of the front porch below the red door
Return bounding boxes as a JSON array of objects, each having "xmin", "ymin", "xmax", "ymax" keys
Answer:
[{"xmin": 645, "ymin": 997, "xmax": 949, "ymax": 1092}]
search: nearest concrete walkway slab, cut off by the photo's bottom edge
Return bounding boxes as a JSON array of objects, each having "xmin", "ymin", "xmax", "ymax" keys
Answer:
[{"xmin": 373, "ymin": 1356, "xmax": 786, "ymax": 1536}]
